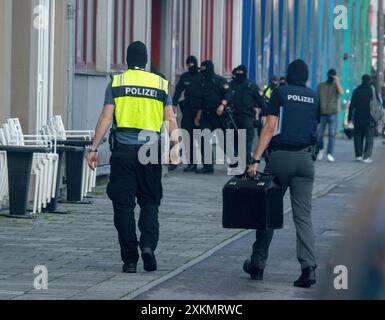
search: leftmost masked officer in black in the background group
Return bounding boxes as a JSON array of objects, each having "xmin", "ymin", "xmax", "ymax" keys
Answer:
[{"xmin": 173, "ymin": 56, "xmax": 202, "ymax": 172}]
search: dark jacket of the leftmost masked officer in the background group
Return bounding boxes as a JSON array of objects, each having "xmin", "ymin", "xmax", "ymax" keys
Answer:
[{"xmin": 173, "ymin": 71, "xmax": 202, "ymax": 114}]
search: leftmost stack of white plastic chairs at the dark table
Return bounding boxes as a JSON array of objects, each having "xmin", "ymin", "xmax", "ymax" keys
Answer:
[{"xmin": 3, "ymin": 119, "xmax": 59, "ymax": 214}]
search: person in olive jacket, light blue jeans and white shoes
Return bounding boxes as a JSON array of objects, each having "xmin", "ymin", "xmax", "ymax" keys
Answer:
[{"xmin": 317, "ymin": 69, "xmax": 344, "ymax": 162}]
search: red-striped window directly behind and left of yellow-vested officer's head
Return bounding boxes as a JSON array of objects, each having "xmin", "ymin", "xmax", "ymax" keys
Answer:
[{"xmin": 111, "ymin": 0, "xmax": 134, "ymax": 70}]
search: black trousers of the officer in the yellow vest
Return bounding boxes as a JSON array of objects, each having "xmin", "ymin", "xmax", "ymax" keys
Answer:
[{"xmin": 107, "ymin": 145, "xmax": 163, "ymax": 264}]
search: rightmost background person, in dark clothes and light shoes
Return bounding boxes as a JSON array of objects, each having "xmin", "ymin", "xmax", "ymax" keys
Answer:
[{"xmin": 348, "ymin": 74, "xmax": 376, "ymax": 163}]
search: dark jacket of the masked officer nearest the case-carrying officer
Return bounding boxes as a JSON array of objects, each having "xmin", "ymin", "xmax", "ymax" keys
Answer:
[{"xmin": 226, "ymin": 80, "xmax": 266, "ymax": 118}]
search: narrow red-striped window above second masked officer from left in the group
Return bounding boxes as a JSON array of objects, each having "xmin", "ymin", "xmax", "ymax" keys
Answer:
[{"xmin": 201, "ymin": 0, "xmax": 214, "ymax": 61}]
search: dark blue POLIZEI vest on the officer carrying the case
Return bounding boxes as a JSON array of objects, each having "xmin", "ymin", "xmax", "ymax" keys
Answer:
[{"xmin": 270, "ymin": 85, "xmax": 319, "ymax": 150}]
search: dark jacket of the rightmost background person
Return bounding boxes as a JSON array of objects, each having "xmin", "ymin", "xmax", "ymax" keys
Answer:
[{"xmin": 348, "ymin": 84, "xmax": 373, "ymax": 128}]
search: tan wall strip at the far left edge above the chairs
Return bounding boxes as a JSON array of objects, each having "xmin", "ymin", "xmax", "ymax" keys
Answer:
[{"xmin": 0, "ymin": 0, "xmax": 12, "ymax": 123}]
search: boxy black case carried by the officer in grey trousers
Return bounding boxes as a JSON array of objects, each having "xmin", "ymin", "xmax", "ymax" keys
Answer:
[{"xmin": 223, "ymin": 173, "xmax": 283, "ymax": 230}]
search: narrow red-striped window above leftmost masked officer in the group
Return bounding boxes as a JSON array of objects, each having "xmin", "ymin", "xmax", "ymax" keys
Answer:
[{"xmin": 176, "ymin": 0, "xmax": 191, "ymax": 74}]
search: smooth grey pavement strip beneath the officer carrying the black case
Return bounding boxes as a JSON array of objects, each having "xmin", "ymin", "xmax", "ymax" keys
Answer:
[{"xmin": 135, "ymin": 152, "xmax": 374, "ymax": 301}]
